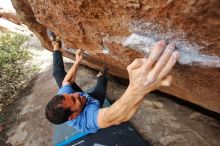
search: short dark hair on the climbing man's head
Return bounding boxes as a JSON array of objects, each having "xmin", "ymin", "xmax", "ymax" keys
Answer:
[{"xmin": 45, "ymin": 94, "xmax": 73, "ymax": 124}]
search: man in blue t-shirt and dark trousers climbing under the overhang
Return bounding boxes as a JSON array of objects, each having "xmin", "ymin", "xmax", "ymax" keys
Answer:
[{"xmin": 46, "ymin": 30, "xmax": 180, "ymax": 133}]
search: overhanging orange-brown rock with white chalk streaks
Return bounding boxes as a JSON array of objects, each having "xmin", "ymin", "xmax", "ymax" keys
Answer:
[{"xmin": 12, "ymin": 0, "xmax": 220, "ymax": 113}]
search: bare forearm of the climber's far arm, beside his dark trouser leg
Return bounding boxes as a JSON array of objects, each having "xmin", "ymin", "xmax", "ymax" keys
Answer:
[{"xmin": 63, "ymin": 62, "xmax": 79, "ymax": 84}]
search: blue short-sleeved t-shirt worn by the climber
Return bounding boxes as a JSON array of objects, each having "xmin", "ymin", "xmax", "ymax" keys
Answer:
[{"xmin": 58, "ymin": 85, "xmax": 100, "ymax": 133}]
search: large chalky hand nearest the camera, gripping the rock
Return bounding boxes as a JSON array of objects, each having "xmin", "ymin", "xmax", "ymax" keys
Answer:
[{"xmin": 127, "ymin": 40, "xmax": 180, "ymax": 96}]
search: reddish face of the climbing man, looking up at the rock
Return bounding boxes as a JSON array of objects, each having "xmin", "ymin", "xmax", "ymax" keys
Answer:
[{"xmin": 62, "ymin": 93, "xmax": 86, "ymax": 120}]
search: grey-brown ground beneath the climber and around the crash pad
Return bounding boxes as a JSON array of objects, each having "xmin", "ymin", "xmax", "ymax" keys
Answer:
[{"xmin": 0, "ymin": 34, "xmax": 220, "ymax": 146}]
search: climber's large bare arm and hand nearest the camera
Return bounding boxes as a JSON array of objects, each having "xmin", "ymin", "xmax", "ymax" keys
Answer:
[{"xmin": 98, "ymin": 41, "xmax": 180, "ymax": 128}]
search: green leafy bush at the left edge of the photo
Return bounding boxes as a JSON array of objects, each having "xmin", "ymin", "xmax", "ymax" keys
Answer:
[{"xmin": 0, "ymin": 32, "xmax": 36, "ymax": 116}]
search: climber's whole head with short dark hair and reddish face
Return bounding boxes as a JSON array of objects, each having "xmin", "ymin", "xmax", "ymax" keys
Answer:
[{"xmin": 45, "ymin": 93, "xmax": 86, "ymax": 124}]
